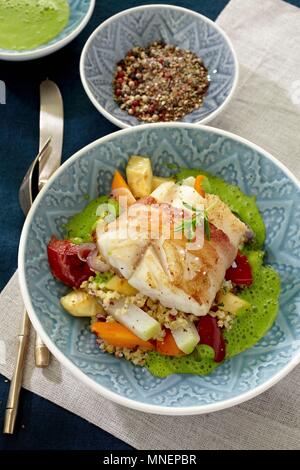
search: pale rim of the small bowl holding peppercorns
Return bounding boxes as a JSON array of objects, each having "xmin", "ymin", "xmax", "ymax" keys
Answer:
[{"xmin": 79, "ymin": 4, "xmax": 239, "ymax": 129}]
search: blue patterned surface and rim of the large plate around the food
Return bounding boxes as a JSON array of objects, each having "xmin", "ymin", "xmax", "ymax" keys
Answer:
[{"xmin": 19, "ymin": 123, "xmax": 300, "ymax": 414}]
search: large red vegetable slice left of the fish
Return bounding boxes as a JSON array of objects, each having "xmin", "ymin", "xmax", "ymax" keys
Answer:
[{"xmin": 47, "ymin": 237, "xmax": 95, "ymax": 288}]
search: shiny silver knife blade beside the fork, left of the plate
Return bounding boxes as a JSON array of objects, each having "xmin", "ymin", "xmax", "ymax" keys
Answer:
[{"xmin": 38, "ymin": 80, "xmax": 64, "ymax": 191}]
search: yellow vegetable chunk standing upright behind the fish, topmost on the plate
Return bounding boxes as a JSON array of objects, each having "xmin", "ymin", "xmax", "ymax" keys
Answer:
[{"xmin": 126, "ymin": 155, "xmax": 153, "ymax": 198}]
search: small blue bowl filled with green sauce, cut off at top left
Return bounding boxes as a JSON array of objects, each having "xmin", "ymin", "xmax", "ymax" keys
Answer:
[{"xmin": 0, "ymin": 0, "xmax": 95, "ymax": 61}]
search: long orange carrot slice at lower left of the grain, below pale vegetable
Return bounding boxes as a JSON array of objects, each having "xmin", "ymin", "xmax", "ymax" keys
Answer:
[{"xmin": 91, "ymin": 322, "xmax": 154, "ymax": 350}]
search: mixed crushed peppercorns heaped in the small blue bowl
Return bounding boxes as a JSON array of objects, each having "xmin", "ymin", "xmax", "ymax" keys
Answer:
[{"xmin": 113, "ymin": 42, "xmax": 209, "ymax": 122}]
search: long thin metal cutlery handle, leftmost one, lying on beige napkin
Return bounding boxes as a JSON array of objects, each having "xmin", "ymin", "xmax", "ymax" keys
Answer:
[{"xmin": 3, "ymin": 311, "xmax": 30, "ymax": 434}]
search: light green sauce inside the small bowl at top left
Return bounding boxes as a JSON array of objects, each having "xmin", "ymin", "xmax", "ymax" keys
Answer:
[{"xmin": 0, "ymin": 0, "xmax": 70, "ymax": 51}]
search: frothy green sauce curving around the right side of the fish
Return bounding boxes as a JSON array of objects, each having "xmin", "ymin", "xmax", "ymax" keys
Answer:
[{"xmin": 146, "ymin": 170, "xmax": 280, "ymax": 377}]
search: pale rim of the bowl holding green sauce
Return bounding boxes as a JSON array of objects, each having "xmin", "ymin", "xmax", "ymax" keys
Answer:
[{"xmin": 0, "ymin": 0, "xmax": 96, "ymax": 62}]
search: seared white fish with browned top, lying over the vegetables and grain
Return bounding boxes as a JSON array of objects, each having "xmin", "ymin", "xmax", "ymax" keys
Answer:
[{"xmin": 97, "ymin": 182, "xmax": 247, "ymax": 316}]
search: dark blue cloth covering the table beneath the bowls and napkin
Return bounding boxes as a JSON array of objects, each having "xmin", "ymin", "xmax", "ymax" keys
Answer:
[{"xmin": 0, "ymin": 0, "xmax": 300, "ymax": 450}]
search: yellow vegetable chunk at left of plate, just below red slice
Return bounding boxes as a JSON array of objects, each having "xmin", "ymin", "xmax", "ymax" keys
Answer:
[{"xmin": 60, "ymin": 289, "xmax": 103, "ymax": 317}]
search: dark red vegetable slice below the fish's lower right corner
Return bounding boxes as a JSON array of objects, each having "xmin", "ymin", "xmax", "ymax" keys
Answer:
[{"xmin": 198, "ymin": 315, "xmax": 225, "ymax": 362}]
